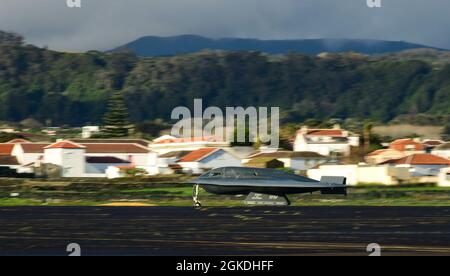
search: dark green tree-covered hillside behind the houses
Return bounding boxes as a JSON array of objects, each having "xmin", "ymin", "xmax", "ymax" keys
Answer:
[{"xmin": 0, "ymin": 32, "xmax": 450, "ymax": 126}]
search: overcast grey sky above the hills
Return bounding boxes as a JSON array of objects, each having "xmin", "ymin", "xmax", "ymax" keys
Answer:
[{"xmin": 0, "ymin": 0, "xmax": 450, "ymax": 51}]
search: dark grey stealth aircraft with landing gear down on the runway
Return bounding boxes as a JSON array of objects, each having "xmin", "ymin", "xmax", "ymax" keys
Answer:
[{"xmin": 191, "ymin": 167, "xmax": 347, "ymax": 206}]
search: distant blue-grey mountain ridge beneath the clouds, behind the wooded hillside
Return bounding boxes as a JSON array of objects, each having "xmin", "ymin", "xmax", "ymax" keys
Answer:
[{"xmin": 108, "ymin": 35, "xmax": 446, "ymax": 57}]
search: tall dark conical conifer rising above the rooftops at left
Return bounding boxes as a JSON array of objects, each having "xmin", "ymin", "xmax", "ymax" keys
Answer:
[{"xmin": 103, "ymin": 91, "xmax": 131, "ymax": 138}]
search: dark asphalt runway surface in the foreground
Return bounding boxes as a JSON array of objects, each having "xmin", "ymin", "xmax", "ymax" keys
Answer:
[{"xmin": 0, "ymin": 207, "xmax": 450, "ymax": 256}]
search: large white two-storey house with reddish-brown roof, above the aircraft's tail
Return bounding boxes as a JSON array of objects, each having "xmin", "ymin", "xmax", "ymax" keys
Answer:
[{"xmin": 294, "ymin": 126, "xmax": 360, "ymax": 156}]
